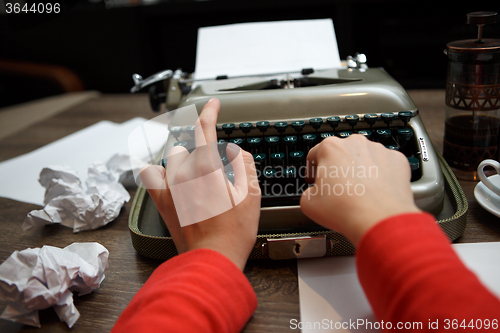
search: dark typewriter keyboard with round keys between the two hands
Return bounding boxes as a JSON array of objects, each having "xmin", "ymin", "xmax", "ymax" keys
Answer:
[{"xmin": 166, "ymin": 111, "xmax": 421, "ymax": 207}]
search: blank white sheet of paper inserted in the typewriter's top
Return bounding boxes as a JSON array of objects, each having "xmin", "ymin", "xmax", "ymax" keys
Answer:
[{"xmin": 195, "ymin": 19, "xmax": 341, "ymax": 79}]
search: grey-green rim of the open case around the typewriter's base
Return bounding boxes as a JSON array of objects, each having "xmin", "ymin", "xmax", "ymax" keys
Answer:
[{"xmin": 129, "ymin": 152, "xmax": 468, "ymax": 260}]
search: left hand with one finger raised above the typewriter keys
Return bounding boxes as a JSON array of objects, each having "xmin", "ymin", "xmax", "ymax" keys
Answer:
[{"xmin": 140, "ymin": 98, "xmax": 261, "ymax": 270}]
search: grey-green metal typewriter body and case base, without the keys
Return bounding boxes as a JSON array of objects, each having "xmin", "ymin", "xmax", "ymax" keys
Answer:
[{"xmin": 129, "ymin": 68, "xmax": 467, "ymax": 259}]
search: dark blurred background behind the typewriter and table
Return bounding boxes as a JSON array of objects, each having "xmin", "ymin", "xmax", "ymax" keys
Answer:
[{"xmin": 0, "ymin": 0, "xmax": 500, "ymax": 107}]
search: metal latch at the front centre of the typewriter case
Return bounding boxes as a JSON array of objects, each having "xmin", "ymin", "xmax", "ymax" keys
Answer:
[{"xmin": 262, "ymin": 235, "xmax": 327, "ymax": 260}]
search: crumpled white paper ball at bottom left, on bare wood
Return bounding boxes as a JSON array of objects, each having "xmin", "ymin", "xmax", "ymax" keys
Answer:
[{"xmin": 0, "ymin": 243, "xmax": 109, "ymax": 328}]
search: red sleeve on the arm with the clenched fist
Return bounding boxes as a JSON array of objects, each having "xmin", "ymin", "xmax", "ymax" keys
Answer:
[{"xmin": 357, "ymin": 213, "xmax": 500, "ymax": 332}]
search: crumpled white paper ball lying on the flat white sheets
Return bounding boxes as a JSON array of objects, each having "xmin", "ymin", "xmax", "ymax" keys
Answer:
[{"xmin": 23, "ymin": 154, "xmax": 144, "ymax": 232}]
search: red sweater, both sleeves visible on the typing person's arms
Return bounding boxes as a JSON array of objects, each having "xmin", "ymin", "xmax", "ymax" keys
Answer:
[{"xmin": 112, "ymin": 214, "xmax": 500, "ymax": 333}]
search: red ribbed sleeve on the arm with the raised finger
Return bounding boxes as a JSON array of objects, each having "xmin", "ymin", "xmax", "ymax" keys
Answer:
[{"xmin": 112, "ymin": 249, "xmax": 257, "ymax": 333}]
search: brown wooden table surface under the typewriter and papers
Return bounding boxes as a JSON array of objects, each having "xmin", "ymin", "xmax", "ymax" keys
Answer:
[{"xmin": 0, "ymin": 90, "xmax": 500, "ymax": 333}]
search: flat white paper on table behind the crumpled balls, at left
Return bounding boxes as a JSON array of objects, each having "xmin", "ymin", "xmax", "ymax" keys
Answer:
[{"xmin": 0, "ymin": 118, "xmax": 168, "ymax": 206}]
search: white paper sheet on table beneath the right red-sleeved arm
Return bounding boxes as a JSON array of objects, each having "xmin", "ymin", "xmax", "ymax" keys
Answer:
[{"xmin": 296, "ymin": 242, "xmax": 500, "ymax": 333}]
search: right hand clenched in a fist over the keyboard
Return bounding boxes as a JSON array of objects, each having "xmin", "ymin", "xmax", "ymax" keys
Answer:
[{"xmin": 300, "ymin": 134, "xmax": 420, "ymax": 246}]
